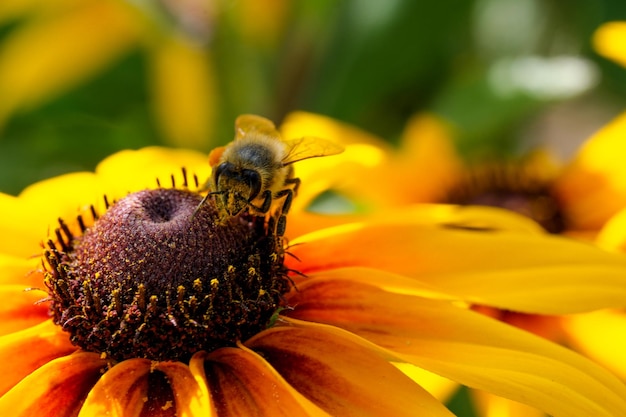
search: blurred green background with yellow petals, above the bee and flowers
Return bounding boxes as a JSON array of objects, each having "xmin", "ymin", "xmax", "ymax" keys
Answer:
[{"xmin": 0, "ymin": 0, "xmax": 626, "ymax": 200}]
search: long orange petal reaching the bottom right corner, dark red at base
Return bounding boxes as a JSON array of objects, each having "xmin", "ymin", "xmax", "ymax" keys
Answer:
[{"xmin": 286, "ymin": 280, "xmax": 626, "ymax": 416}]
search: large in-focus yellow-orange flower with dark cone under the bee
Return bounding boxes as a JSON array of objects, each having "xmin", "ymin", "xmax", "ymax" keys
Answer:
[{"xmin": 0, "ymin": 148, "xmax": 626, "ymax": 416}]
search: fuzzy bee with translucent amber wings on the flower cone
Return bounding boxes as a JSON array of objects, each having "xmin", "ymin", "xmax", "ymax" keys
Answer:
[{"xmin": 196, "ymin": 114, "xmax": 343, "ymax": 236}]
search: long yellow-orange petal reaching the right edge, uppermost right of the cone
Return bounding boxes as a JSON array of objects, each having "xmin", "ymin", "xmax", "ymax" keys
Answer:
[{"xmin": 286, "ymin": 213, "xmax": 626, "ymax": 314}]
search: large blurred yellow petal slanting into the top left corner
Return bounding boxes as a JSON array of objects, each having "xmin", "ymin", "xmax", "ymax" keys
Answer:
[{"xmin": 0, "ymin": 0, "xmax": 138, "ymax": 122}]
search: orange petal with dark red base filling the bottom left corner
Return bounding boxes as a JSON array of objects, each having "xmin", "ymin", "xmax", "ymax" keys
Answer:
[{"xmin": 0, "ymin": 352, "xmax": 106, "ymax": 417}]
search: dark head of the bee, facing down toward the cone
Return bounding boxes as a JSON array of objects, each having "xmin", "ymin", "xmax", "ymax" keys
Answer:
[{"xmin": 213, "ymin": 162, "xmax": 263, "ymax": 216}]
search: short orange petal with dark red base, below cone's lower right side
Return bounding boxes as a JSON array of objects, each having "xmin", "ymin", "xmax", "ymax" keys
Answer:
[{"xmin": 196, "ymin": 346, "xmax": 328, "ymax": 417}]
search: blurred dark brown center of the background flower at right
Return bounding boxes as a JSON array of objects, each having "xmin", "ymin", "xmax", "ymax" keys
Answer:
[{"xmin": 445, "ymin": 165, "xmax": 566, "ymax": 233}]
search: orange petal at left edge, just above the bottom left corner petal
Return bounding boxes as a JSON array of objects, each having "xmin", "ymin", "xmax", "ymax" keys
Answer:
[{"xmin": 0, "ymin": 320, "xmax": 76, "ymax": 394}]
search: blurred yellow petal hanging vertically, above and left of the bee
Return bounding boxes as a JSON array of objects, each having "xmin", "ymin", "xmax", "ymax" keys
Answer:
[{"xmin": 150, "ymin": 37, "xmax": 217, "ymax": 148}]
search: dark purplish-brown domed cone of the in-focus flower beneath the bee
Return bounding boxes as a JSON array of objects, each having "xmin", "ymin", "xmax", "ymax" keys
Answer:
[{"xmin": 45, "ymin": 189, "xmax": 289, "ymax": 360}]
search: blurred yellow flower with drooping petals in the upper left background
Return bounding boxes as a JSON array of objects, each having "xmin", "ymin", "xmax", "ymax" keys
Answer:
[{"xmin": 0, "ymin": 0, "xmax": 287, "ymax": 148}]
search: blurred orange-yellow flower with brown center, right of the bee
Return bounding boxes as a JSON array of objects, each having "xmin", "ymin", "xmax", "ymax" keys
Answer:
[{"xmin": 283, "ymin": 112, "xmax": 626, "ymax": 238}]
